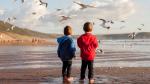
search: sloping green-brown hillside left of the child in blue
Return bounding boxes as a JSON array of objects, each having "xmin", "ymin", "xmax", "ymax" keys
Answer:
[{"xmin": 0, "ymin": 21, "xmax": 58, "ymax": 38}]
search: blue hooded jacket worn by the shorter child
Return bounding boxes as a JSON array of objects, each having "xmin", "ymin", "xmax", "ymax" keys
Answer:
[{"xmin": 57, "ymin": 36, "xmax": 76, "ymax": 61}]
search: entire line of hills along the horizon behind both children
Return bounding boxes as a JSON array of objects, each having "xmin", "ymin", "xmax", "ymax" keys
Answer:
[{"xmin": 0, "ymin": 21, "xmax": 150, "ymax": 40}]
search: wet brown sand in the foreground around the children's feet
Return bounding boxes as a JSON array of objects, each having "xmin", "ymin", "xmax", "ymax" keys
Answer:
[{"xmin": 0, "ymin": 67, "xmax": 150, "ymax": 84}]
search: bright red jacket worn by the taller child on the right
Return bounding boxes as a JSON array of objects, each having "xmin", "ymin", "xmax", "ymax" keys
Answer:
[{"xmin": 77, "ymin": 33, "xmax": 98, "ymax": 61}]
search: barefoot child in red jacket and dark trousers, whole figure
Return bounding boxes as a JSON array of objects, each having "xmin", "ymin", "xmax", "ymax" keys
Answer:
[{"xmin": 77, "ymin": 22, "xmax": 98, "ymax": 84}]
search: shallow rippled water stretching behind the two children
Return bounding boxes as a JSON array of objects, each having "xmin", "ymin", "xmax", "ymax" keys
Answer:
[{"xmin": 0, "ymin": 39, "xmax": 150, "ymax": 69}]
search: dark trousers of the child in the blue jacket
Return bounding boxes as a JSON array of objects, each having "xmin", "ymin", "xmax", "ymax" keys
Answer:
[{"xmin": 62, "ymin": 60, "xmax": 72, "ymax": 78}]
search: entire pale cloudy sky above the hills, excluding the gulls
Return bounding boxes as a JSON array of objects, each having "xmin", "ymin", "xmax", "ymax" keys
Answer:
[{"xmin": 0, "ymin": 0, "xmax": 150, "ymax": 34}]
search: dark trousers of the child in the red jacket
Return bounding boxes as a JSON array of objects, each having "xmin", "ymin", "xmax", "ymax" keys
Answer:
[{"xmin": 80, "ymin": 60, "xmax": 94, "ymax": 80}]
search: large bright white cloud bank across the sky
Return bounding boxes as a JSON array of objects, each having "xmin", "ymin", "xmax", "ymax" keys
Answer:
[{"xmin": 0, "ymin": 0, "xmax": 135, "ymax": 33}]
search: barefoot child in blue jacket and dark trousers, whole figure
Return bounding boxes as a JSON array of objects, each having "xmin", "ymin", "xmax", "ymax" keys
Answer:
[{"xmin": 57, "ymin": 26, "xmax": 76, "ymax": 81}]
